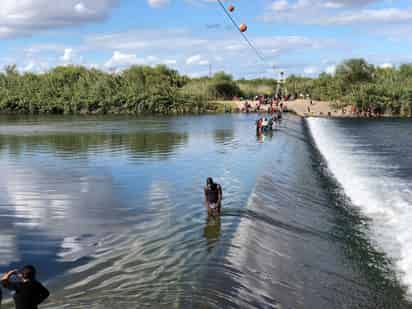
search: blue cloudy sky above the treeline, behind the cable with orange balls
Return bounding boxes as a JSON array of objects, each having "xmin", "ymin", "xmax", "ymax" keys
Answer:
[{"xmin": 0, "ymin": 0, "xmax": 412, "ymax": 79}]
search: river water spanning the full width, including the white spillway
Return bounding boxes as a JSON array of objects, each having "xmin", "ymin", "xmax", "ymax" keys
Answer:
[{"xmin": 0, "ymin": 115, "xmax": 412, "ymax": 309}]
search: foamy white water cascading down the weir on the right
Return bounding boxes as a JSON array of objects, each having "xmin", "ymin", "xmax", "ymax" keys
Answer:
[{"xmin": 307, "ymin": 118, "xmax": 412, "ymax": 296}]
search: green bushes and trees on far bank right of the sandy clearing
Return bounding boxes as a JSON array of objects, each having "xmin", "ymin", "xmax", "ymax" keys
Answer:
[{"xmin": 286, "ymin": 59, "xmax": 412, "ymax": 116}]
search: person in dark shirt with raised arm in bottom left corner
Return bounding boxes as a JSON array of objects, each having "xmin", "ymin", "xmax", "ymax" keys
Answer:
[{"xmin": 1, "ymin": 265, "xmax": 50, "ymax": 309}]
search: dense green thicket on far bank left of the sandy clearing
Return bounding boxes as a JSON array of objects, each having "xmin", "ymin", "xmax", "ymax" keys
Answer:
[{"xmin": 0, "ymin": 66, "xmax": 207, "ymax": 114}]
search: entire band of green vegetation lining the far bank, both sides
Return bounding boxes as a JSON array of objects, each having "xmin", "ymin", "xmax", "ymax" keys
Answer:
[{"xmin": 0, "ymin": 59, "xmax": 412, "ymax": 116}]
